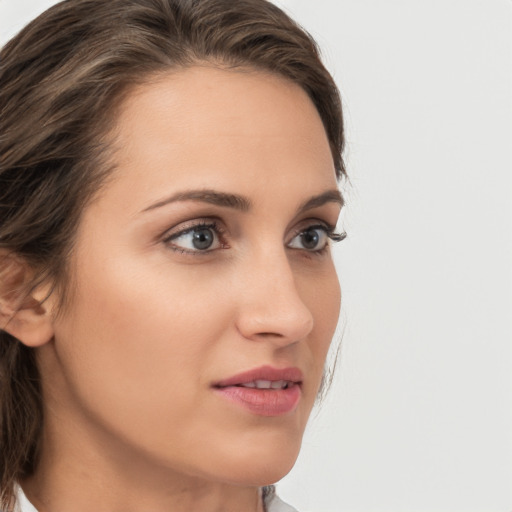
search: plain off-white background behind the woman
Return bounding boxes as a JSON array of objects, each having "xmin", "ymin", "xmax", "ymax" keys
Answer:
[{"xmin": 0, "ymin": 0, "xmax": 512, "ymax": 512}]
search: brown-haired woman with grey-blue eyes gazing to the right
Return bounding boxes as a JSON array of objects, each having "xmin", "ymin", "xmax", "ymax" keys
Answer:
[{"xmin": 0, "ymin": 0, "xmax": 345, "ymax": 512}]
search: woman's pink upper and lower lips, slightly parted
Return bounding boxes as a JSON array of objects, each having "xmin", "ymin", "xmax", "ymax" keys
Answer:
[{"xmin": 213, "ymin": 366, "xmax": 303, "ymax": 416}]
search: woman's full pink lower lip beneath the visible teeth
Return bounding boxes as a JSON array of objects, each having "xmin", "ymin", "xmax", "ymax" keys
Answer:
[{"xmin": 215, "ymin": 384, "xmax": 301, "ymax": 416}]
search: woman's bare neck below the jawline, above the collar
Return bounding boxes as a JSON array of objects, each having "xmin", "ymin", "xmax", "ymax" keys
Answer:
[{"xmin": 20, "ymin": 414, "xmax": 264, "ymax": 512}]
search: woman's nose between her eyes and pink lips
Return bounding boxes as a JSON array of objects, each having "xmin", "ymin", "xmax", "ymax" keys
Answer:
[{"xmin": 236, "ymin": 250, "xmax": 314, "ymax": 346}]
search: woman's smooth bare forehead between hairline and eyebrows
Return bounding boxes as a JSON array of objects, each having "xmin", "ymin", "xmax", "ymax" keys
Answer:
[{"xmin": 105, "ymin": 66, "xmax": 336, "ymax": 206}]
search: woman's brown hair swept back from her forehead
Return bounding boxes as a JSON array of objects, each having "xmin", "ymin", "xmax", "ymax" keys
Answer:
[{"xmin": 0, "ymin": 0, "xmax": 345, "ymax": 510}]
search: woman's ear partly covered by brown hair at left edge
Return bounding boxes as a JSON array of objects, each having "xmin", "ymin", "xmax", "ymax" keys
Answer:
[{"xmin": 0, "ymin": 251, "xmax": 53, "ymax": 347}]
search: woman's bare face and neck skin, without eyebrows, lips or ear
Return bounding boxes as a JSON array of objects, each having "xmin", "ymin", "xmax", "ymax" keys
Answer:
[{"xmin": 23, "ymin": 66, "xmax": 340, "ymax": 512}]
